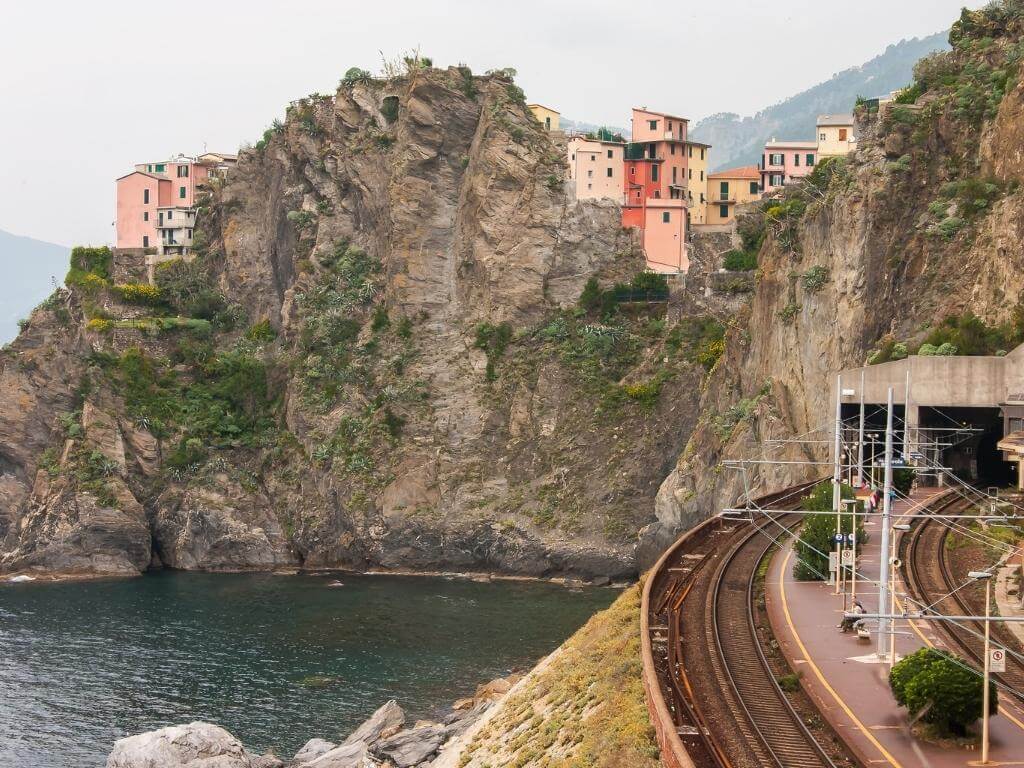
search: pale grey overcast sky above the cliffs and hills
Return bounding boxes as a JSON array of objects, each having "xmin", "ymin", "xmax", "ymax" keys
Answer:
[{"xmin": 0, "ymin": 0, "xmax": 984, "ymax": 245}]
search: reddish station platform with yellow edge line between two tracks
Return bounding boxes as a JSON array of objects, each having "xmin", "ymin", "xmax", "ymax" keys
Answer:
[{"xmin": 765, "ymin": 488, "xmax": 1024, "ymax": 768}]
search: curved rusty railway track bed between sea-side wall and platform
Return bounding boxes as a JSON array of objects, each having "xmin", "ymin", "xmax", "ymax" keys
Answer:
[{"xmin": 641, "ymin": 481, "xmax": 847, "ymax": 768}]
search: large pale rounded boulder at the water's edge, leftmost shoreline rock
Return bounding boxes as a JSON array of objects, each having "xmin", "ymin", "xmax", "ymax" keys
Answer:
[{"xmin": 106, "ymin": 721, "xmax": 253, "ymax": 768}]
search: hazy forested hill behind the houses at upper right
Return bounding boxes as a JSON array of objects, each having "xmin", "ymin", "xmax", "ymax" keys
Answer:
[{"xmin": 690, "ymin": 32, "xmax": 949, "ymax": 170}]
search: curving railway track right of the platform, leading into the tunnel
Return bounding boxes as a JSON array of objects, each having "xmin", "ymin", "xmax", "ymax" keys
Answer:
[{"xmin": 900, "ymin": 496, "xmax": 1024, "ymax": 703}]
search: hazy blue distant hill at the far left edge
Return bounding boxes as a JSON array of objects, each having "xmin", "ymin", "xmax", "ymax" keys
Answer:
[{"xmin": 0, "ymin": 229, "xmax": 71, "ymax": 344}]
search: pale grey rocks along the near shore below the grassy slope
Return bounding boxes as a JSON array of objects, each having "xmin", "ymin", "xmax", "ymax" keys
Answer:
[{"xmin": 106, "ymin": 674, "xmax": 522, "ymax": 768}]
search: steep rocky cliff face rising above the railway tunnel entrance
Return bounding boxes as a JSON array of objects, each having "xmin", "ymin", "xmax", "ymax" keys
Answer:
[{"xmin": 641, "ymin": 2, "xmax": 1024, "ymax": 553}]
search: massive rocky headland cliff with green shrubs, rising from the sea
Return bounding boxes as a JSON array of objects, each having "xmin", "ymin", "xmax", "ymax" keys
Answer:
[{"xmin": 0, "ymin": 62, "xmax": 720, "ymax": 575}]
